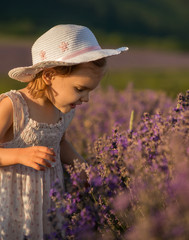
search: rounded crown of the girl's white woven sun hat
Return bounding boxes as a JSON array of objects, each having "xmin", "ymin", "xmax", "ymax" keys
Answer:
[{"xmin": 32, "ymin": 24, "xmax": 101, "ymax": 65}]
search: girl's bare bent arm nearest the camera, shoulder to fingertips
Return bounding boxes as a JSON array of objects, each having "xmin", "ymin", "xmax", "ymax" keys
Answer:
[{"xmin": 0, "ymin": 97, "xmax": 55, "ymax": 170}]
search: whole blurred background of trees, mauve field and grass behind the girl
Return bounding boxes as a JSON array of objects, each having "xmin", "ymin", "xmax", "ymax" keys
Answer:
[{"xmin": 0, "ymin": 0, "xmax": 189, "ymax": 97}]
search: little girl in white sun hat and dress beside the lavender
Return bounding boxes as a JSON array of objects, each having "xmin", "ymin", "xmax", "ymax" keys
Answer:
[{"xmin": 0, "ymin": 24, "xmax": 127, "ymax": 240}]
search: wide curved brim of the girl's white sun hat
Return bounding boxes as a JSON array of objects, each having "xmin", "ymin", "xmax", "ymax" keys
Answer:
[{"xmin": 8, "ymin": 47, "xmax": 128, "ymax": 82}]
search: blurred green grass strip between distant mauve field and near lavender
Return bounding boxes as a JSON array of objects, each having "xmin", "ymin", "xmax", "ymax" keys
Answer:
[{"xmin": 0, "ymin": 69, "xmax": 189, "ymax": 98}]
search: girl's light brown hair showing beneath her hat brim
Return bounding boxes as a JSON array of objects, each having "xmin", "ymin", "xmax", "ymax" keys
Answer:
[{"xmin": 27, "ymin": 58, "xmax": 106, "ymax": 98}]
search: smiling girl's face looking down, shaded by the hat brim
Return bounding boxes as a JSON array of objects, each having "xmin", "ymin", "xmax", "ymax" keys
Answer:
[{"xmin": 46, "ymin": 63, "xmax": 103, "ymax": 113}]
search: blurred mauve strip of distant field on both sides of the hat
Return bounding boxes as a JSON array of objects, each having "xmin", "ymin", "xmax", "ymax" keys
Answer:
[{"xmin": 0, "ymin": 44, "xmax": 189, "ymax": 74}]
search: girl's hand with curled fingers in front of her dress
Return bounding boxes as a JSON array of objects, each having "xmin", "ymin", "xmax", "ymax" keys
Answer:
[{"xmin": 17, "ymin": 146, "xmax": 56, "ymax": 171}]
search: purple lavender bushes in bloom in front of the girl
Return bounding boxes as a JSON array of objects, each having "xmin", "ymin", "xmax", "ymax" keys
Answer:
[{"xmin": 46, "ymin": 85, "xmax": 189, "ymax": 240}]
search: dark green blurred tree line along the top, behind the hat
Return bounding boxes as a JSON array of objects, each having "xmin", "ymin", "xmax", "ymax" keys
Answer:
[{"xmin": 0, "ymin": 0, "xmax": 189, "ymax": 49}]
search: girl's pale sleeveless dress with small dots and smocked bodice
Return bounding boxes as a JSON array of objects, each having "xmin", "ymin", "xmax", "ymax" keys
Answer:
[{"xmin": 0, "ymin": 90, "xmax": 74, "ymax": 240}]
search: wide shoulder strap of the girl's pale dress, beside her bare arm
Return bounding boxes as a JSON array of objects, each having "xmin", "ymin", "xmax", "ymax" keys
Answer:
[{"xmin": 0, "ymin": 90, "xmax": 26, "ymax": 137}]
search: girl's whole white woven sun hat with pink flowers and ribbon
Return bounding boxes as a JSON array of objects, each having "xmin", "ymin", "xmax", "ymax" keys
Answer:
[{"xmin": 8, "ymin": 24, "xmax": 128, "ymax": 82}]
